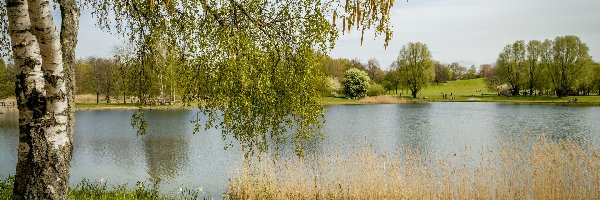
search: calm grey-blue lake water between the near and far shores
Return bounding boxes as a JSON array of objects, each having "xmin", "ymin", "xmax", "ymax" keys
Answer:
[{"xmin": 0, "ymin": 102, "xmax": 600, "ymax": 197}]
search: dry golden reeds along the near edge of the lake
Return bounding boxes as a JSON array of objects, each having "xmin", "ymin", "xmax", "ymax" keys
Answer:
[{"xmin": 226, "ymin": 136, "xmax": 600, "ymax": 199}]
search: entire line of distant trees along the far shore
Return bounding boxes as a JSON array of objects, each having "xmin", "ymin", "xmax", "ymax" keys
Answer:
[{"xmin": 0, "ymin": 36, "xmax": 600, "ymax": 103}]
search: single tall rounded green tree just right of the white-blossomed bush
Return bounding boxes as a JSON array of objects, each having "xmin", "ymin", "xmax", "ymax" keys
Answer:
[{"xmin": 396, "ymin": 42, "xmax": 435, "ymax": 98}]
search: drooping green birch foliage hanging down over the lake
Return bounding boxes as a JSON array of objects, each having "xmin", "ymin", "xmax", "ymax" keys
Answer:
[{"xmin": 55, "ymin": 0, "xmax": 393, "ymax": 153}]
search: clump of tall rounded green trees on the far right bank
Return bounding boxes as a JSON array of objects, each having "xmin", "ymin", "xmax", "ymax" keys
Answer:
[{"xmin": 481, "ymin": 35, "xmax": 600, "ymax": 97}]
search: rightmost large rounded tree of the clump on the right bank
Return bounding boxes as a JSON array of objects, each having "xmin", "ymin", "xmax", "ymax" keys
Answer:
[{"xmin": 549, "ymin": 35, "xmax": 591, "ymax": 97}]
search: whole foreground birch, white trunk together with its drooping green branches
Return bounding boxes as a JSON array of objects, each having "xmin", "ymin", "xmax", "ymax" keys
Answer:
[{"xmin": 0, "ymin": 0, "xmax": 393, "ymax": 199}]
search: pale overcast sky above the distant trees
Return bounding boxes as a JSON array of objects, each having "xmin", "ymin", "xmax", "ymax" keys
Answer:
[{"xmin": 76, "ymin": 0, "xmax": 600, "ymax": 69}]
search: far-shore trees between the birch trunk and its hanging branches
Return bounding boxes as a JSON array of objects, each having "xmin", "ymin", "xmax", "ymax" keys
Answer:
[{"xmin": 75, "ymin": 48, "xmax": 180, "ymax": 103}]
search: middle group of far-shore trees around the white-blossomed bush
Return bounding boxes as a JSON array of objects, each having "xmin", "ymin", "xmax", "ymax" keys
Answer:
[{"xmin": 319, "ymin": 42, "xmax": 491, "ymax": 98}]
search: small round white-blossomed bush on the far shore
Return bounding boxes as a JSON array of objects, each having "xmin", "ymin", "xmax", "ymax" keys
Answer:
[{"xmin": 342, "ymin": 68, "xmax": 371, "ymax": 99}]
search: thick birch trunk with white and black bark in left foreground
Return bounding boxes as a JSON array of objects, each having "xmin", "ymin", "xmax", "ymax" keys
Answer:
[{"xmin": 6, "ymin": 0, "xmax": 78, "ymax": 199}]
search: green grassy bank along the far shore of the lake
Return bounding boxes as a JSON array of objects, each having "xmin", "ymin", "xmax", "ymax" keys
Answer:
[{"xmin": 0, "ymin": 79, "xmax": 600, "ymax": 112}]
